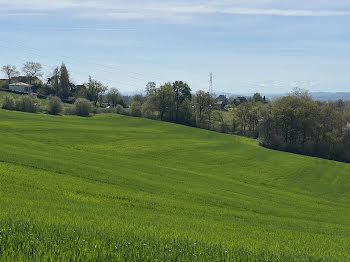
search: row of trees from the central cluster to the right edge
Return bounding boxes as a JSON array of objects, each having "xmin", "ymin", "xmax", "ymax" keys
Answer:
[{"xmin": 129, "ymin": 85, "xmax": 350, "ymax": 162}]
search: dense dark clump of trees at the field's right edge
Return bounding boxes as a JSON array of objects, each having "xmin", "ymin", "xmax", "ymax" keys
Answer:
[{"xmin": 258, "ymin": 92, "xmax": 350, "ymax": 162}]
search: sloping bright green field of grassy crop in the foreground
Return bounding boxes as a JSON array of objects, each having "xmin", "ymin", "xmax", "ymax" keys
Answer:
[{"xmin": 0, "ymin": 110, "xmax": 350, "ymax": 261}]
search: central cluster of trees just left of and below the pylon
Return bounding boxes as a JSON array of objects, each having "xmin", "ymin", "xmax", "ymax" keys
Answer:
[{"xmin": 129, "ymin": 81, "xmax": 220, "ymax": 129}]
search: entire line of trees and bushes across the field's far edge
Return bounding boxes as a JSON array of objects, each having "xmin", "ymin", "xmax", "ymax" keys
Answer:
[{"xmin": 3, "ymin": 62, "xmax": 350, "ymax": 162}]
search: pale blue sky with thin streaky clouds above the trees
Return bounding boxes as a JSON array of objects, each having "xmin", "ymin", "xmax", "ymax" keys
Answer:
[{"xmin": 0, "ymin": 0, "xmax": 350, "ymax": 94}]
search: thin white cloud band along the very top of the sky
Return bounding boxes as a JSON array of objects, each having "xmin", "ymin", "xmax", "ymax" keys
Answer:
[{"xmin": 0, "ymin": 0, "xmax": 350, "ymax": 21}]
